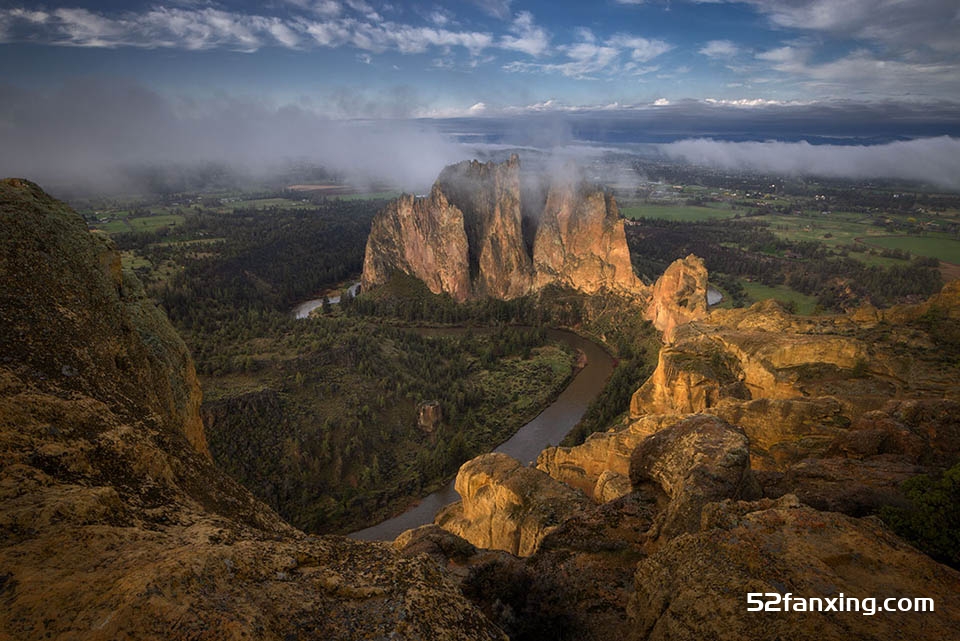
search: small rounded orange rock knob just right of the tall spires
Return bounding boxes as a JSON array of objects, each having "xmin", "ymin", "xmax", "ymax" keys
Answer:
[{"xmin": 645, "ymin": 254, "xmax": 708, "ymax": 343}]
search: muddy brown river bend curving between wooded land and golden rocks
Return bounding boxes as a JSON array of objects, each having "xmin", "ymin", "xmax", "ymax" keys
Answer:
[{"xmin": 350, "ymin": 329, "xmax": 614, "ymax": 541}]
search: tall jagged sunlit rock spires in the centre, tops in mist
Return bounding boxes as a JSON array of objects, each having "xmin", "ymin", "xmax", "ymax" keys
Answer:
[{"xmin": 362, "ymin": 155, "xmax": 642, "ymax": 301}]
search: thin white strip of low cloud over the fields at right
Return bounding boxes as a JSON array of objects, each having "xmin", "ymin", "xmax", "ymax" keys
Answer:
[{"xmin": 660, "ymin": 136, "xmax": 960, "ymax": 189}]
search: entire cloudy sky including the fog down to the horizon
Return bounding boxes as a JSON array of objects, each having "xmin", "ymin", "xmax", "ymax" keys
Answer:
[{"xmin": 0, "ymin": 0, "xmax": 960, "ymax": 192}]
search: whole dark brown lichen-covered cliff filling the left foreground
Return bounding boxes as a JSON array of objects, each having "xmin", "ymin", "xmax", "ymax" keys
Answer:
[{"xmin": 0, "ymin": 180, "xmax": 503, "ymax": 640}]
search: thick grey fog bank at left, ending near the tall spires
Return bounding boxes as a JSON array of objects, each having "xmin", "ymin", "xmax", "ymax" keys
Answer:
[{"xmin": 0, "ymin": 78, "xmax": 463, "ymax": 191}]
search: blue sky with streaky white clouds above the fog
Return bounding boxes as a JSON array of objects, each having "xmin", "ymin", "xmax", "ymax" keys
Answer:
[{"xmin": 0, "ymin": 0, "xmax": 960, "ymax": 118}]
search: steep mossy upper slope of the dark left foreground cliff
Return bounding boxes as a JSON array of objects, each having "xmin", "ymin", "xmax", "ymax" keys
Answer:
[{"xmin": 0, "ymin": 178, "xmax": 210, "ymax": 458}]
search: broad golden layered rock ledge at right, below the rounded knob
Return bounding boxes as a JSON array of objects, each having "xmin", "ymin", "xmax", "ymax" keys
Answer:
[{"xmin": 631, "ymin": 286, "xmax": 960, "ymax": 416}]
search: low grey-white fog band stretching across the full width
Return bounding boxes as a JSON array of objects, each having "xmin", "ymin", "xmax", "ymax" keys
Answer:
[{"xmin": 0, "ymin": 79, "xmax": 960, "ymax": 193}]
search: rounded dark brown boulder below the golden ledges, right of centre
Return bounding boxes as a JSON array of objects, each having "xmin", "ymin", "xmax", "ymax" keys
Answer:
[{"xmin": 630, "ymin": 416, "xmax": 760, "ymax": 538}]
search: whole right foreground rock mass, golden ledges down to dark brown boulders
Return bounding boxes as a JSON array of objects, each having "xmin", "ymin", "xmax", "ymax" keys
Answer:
[{"xmin": 430, "ymin": 278, "xmax": 960, "ymax": 641}]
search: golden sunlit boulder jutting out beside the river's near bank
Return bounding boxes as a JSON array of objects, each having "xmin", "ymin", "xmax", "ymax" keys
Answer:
[{"xmin": 434, "ymin": 452, "xmax": 589, "ymax": 556}]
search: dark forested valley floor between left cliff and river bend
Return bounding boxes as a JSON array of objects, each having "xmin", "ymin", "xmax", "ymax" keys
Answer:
[{"xmin": 116, "ymin": 200, "xmax": 574, "ymax": 532}]
